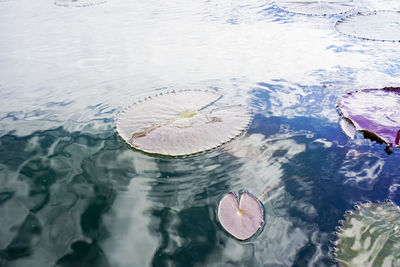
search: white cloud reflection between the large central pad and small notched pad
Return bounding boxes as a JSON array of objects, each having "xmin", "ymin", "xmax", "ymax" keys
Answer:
[{"xmin": 223, "ymin": 130, "xmax": 306, "ymax": 203}]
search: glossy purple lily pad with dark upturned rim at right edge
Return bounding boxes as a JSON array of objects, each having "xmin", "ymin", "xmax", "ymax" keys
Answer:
[{"xmin": 337, "ymin": 87, "xmax": 400, "ymax": 150}]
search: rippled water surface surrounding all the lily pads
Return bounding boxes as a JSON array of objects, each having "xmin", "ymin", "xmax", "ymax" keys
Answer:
[{"xmin": 0, "ymin": 0, "xmax": 400, "ymax": 266}]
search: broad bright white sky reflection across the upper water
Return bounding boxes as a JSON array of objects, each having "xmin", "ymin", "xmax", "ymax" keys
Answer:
[{"xmin": 0, "ymin": 0, "xmax": 400, "ymax": 135}]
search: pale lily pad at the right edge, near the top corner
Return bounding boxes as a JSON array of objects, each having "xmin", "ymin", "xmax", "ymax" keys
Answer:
[{"xmin": 336, "ymin": 11, "xmax": 400, "ymax": 42}]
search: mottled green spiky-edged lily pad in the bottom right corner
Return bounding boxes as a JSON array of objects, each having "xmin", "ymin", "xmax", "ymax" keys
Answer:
[{"xmin": 334, "ymin": 201, "xmax": 400, "ymax": 266}]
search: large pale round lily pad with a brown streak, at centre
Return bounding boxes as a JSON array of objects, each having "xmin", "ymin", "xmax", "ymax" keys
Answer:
[{"xmin": 116, "ymin": 90, "xmax": 251, "ymax": 156}]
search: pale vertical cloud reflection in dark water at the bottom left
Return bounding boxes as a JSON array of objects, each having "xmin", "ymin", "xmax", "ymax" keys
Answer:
[{"xmin": 102, "ymin": 177, "xmax": 159, "ymax": 267}]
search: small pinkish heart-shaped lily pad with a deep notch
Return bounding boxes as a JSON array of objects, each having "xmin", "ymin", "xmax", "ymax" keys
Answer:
[{"xmin": 218, "ymin": 192, "xmax": 264, "ymax": 240}]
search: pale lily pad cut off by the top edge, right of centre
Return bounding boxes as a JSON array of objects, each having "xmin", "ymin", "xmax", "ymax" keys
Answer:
[{"xmin": 276, "ymin": 0, "xmax": 354, "ymax": 16}]
